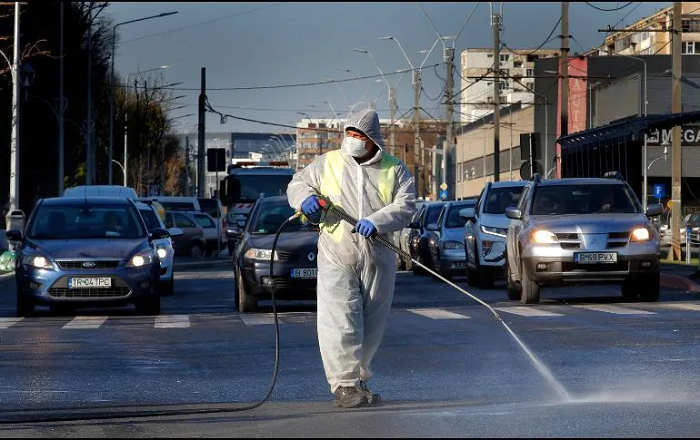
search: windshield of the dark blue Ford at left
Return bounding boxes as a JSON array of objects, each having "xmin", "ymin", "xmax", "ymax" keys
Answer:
[{"xmin": 27, "ymin": 203, "xmax": 146, "ymax": 239}]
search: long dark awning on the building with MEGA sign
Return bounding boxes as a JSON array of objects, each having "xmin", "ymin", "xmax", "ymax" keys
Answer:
[{"xmin": 557, "ymin": 111, "xmax": 700, "ymax": 153}]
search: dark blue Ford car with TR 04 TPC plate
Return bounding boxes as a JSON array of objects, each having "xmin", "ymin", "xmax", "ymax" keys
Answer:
[{"xmin": 7, "ymin": 197, "xmax": 168, "ymax": 316}]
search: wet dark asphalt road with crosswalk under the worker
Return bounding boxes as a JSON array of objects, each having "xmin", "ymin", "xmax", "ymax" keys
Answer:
[{"xmin": 0, "ymin": 264, "xmax": 700, "ymax": 438}]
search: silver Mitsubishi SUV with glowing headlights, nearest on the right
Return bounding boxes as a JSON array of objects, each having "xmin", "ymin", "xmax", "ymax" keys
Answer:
[{"xmin": 506, "ymin": 173, "xmax": 663, "ymax": 304}]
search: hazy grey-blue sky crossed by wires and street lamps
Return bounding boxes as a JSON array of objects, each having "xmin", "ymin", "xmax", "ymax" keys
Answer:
[{"xmin": 107, "ymin": 2, "xmax": 669, "ymax": 132}]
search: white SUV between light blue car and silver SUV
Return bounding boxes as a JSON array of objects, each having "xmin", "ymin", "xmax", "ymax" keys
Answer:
[{"xmin": 462, "ymin": 181, "xmax": 526, "ymax": 289}]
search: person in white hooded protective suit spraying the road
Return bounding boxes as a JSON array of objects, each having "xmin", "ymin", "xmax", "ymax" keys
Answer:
[{"xmin": 287, "ymin": 110, "xmax": 415, "ymax": 408}]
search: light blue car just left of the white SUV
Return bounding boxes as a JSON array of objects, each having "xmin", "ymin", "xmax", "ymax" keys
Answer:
[{"xmin": 428, "ymin": 200, "xmax": 476, "ymax": 280}]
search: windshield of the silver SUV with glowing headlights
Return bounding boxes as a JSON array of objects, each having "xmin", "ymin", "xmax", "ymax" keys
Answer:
[{"xmin": 530, "ymin": 185, "xmax": 639, "ymax": 215}]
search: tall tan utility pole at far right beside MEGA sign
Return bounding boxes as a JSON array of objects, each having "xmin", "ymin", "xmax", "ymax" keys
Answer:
[{"xmin": 668, "ymin": 2, "xmax": 690, "ymax": 261}]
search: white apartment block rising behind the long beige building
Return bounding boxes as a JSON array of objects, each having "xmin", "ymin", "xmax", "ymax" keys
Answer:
[{"xmin": 459, "ymin": 47, "xmax": 559, "ymax": 124}]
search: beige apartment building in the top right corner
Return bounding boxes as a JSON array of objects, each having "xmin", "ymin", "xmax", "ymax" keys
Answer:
[{"xmin": 594, "ymin": 2, "xmax": 700, "ymax": 56}]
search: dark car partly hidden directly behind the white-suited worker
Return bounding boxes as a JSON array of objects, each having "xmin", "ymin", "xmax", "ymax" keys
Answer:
[{"xmin": 233, "ymin": 196, "xmax": 319, "ymax": 313}]
